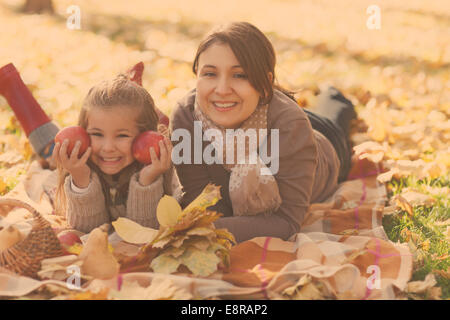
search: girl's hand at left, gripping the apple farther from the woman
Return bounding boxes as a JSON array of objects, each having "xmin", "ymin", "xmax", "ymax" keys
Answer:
[{"xmin": 52, "ymin": 139, "xmax": 92, "ymax": 188}]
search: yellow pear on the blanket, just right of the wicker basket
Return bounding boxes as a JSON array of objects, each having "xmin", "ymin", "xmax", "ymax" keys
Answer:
[{"xmin": 79, "ymin": 228, "xmax": 120, "ymax": 280}]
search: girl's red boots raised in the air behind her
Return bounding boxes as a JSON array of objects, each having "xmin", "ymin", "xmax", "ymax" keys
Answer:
[{"xmin": 0, "ymin": 62, "xmax": 169, "ymax": 168}]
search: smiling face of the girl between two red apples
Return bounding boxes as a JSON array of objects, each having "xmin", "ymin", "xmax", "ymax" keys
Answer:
[{"xmin": 86, "ymin": 106, "xmax": 139, "ymax": 175}]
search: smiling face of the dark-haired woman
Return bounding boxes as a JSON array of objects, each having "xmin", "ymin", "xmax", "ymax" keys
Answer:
[{"xmin": 196, "ymin": 43, "xmax": 260, "ymax": 129}]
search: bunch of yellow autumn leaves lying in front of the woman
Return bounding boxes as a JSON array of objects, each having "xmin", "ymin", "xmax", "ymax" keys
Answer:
[{"xmin": 113, "ymin": 184, "xmax": 236, "ymax": 277}]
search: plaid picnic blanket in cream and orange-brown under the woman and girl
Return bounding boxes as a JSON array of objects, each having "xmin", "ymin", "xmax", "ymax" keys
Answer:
[{"xmin": 0, "ymin": 157, "xmax": 413, "ymax": 299}]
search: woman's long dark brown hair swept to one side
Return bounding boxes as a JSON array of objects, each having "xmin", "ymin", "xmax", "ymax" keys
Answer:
[{"xmin": 192, "ymin": 22, "xmax": 290, "ymax": 104}]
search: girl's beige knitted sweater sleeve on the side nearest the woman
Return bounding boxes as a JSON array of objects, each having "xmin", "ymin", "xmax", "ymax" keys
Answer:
[{"xmin": 126, "ymin": 173, "xmax": 164, "ymax": 229}]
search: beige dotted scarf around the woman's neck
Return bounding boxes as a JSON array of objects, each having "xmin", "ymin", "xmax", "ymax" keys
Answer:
[{"xmin": 194, "ymin": 100, "xmax": 281, "ymax": 216}]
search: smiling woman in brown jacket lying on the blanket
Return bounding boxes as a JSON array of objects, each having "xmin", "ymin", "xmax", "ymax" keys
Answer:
[{"xmin": 171, "ymin": 22, "xmax": 355, "ymax": 242}]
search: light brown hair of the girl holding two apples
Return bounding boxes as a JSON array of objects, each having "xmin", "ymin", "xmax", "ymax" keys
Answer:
[{"xmin": 56, "ymin": 74, "xmax": 158, "ymax": 214}]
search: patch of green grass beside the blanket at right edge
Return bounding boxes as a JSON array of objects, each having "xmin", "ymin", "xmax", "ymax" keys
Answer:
[{"xmin": 383, "ymin": 176, "xmax": 450, "ymax": 299}]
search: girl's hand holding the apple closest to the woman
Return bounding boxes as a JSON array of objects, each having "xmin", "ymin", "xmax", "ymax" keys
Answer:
[{"xmin": 139, "ymin": 137, "xmax": 173, "ymax": 186}]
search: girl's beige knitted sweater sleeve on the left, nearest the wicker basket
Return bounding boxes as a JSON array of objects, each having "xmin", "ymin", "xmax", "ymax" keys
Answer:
[{"xmin": 64, "ymin": 173, "xmax": 109, "ymax": 233}]
